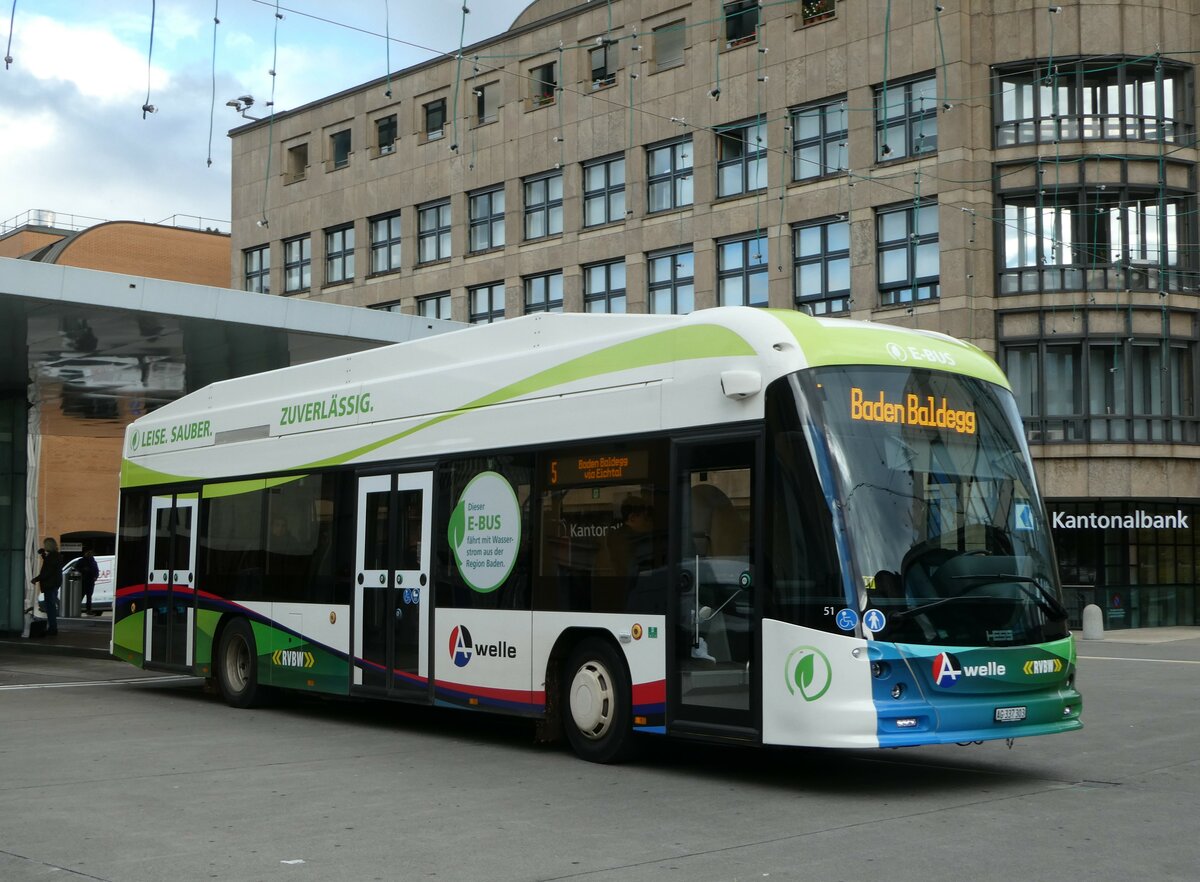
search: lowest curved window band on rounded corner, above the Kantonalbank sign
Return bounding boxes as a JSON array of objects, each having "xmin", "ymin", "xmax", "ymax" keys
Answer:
[{"xmin": 1003, "ymin": 331, "xmax": 1200, "ymax": 444}]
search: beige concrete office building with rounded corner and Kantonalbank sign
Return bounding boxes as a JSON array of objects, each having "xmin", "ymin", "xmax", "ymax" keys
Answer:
[{"xmin": 232, "ymin": 0, "xmax": 1200, "ymax": 626}]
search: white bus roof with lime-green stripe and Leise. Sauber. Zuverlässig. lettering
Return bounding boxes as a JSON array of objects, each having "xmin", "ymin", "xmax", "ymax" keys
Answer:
[{"xmin": 121, "ymin": 307, "xmax": 1008, "ymax": 487}]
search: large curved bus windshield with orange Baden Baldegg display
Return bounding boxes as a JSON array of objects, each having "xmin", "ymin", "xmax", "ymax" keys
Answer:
[{"xmin": 802, "ymin": 367, "xmax": 1067, "ymax": 647}]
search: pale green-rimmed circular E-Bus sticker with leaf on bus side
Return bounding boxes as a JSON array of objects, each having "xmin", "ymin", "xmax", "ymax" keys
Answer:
[{"xmin": 446, "ymin": 472, "xmax": 521, "ymax": 594}]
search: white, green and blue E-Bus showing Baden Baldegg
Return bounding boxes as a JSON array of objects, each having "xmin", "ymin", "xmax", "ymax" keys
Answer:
[{"xmin": 113, "ymin": 308, "xmax": 1081, "ymax": 762}]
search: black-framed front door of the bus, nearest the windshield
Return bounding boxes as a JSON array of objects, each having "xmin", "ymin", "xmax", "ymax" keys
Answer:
[{"xmin": 667, "ymin": 438, "xmax": 761, "ymax": 740}]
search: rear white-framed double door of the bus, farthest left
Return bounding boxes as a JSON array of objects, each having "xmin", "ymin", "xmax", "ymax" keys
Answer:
[{"xmin": 145, "ymin": 493, "xmax": 199, "ymax": 667}]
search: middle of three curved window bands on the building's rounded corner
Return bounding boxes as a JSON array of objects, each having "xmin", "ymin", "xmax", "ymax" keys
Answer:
[{"xmin": 997, "ymin": 184, "xmax": 1196, "ymax": 294}]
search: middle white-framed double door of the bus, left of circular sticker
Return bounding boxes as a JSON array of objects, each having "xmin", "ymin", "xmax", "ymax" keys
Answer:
[{"xmin": 352, "ymin": 472, "xmax": 433, "ymax": 701}]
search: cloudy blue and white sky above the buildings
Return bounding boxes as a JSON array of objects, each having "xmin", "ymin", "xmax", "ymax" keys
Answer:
[{"xmin": 0, "ymin": 0, "xmax": 527, "ymax": 231}]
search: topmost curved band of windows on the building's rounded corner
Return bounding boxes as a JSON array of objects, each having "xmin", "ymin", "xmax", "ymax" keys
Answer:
[{"xmin": 994, "ymin": 58, "xmax": 1194, "ymax": 148}]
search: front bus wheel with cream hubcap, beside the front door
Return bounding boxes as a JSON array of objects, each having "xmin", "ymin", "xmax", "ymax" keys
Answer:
[{"xmin": 563, "ymin": 638, "xmax": 634, "ymax": 762}]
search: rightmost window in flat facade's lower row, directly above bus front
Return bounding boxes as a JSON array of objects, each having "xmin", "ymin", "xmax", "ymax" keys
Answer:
[{"xmin": 876, "ymin": 202, "xmax": 940, "ymax": 306}]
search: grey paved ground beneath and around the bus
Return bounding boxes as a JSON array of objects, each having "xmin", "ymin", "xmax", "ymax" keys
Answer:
[{"xmin": 0, "ymin": 629, "xmax": 1200, "ymax": 882}]
